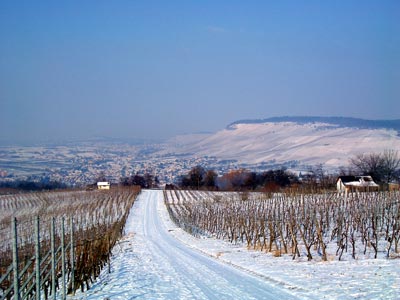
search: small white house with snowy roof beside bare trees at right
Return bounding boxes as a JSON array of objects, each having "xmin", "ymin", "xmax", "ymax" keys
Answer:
[{"xmin": 336, "ymin": 176, "xmax": 379, "ymax": 193}]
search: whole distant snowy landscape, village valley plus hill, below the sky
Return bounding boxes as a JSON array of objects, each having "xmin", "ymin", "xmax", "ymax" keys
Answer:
[{"xmin": 0, "ymin": 117, "xmax": 400, "ymax": 186}]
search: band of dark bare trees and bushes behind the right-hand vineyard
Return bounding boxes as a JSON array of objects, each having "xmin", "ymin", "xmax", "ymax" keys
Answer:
[{"xmin": 178, "ymin": 150, "xmax": 400, "ymax": 192}]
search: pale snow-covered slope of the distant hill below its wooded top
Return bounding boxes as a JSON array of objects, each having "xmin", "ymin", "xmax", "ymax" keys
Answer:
[{"xmin": 166, "ymin": 122, "xmax": 400, "ymax": 168}]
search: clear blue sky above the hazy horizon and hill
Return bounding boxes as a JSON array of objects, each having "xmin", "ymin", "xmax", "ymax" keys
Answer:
[{"xmin": 0, "ymin": 0, "xmax": 400, "ymax": 142}]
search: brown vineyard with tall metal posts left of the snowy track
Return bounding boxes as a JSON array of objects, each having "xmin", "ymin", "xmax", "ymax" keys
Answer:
[{"xmin": 0, "ymin": 189, "xmax": 139, "ymax": 299}]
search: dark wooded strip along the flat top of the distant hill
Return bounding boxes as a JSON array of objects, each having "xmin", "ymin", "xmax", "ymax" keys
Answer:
[{"xmin": 227, "ymin": 116, "xmax": 400, "ymax": 133}]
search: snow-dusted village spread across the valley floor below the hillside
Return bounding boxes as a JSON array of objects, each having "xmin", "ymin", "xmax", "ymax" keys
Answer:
[{"xmin": 0, "ymin": 138, "xmax": 300, "ymax": 187}]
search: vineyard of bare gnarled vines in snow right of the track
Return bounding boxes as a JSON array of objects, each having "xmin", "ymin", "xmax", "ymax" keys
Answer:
[{"xmin": 165, "ymin": 190, "xmax": 400, "ymax": 261}]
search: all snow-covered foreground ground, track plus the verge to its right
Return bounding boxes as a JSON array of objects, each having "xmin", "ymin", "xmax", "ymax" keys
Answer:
[{"xmin": 70, "ymin": 191, "xmax": 400, "ymax": 299}]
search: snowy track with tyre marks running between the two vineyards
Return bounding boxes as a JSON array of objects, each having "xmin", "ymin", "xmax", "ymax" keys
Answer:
[{"xmin": 75, "ymin": 191, "xmax": 294, "ymax": 300}]
